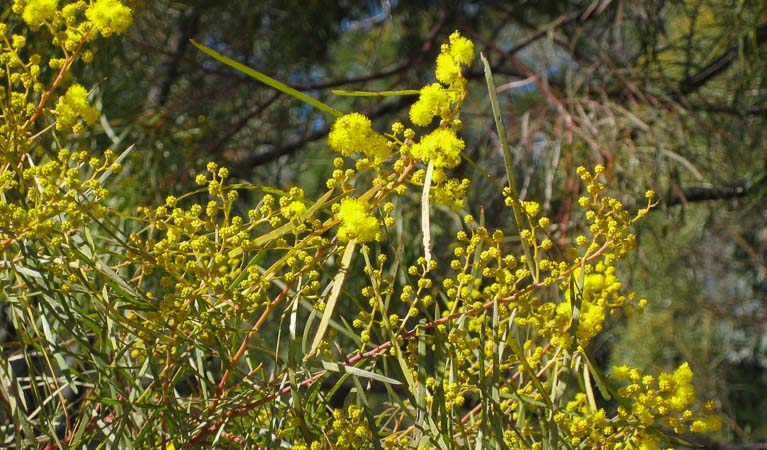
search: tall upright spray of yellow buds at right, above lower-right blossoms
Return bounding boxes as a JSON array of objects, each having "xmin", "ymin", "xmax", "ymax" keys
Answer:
[{"xmin": 506, "ymin": 166, "xmax": 654, "ymax": 348}]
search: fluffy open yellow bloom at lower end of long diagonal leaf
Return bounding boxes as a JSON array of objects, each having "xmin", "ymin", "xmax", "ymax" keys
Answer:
[{"xmin": 328, "ymin": 113, "xmax": 391, "ymax": 164}]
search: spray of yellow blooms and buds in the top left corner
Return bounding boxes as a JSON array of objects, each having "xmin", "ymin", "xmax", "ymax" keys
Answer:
[{"xmin": 0, "ymin": 0, "xmax": 132, "ymax": 163}]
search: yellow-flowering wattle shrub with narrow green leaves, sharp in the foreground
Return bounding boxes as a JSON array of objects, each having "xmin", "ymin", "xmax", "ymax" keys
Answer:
[{"xmin": 0, "ymin": 0, "xmax": 719, "ymax": 450}]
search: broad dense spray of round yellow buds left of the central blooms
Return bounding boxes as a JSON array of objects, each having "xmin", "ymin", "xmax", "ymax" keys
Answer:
[{"xmin": 130, "ymin": 162, "xmax": 328, "ymax": 348}]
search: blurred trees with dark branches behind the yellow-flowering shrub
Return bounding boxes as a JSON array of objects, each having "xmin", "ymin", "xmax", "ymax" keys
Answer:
[{"xmin": 63, "ymin": 0, "xmax": 767, "ymax": 442}]
